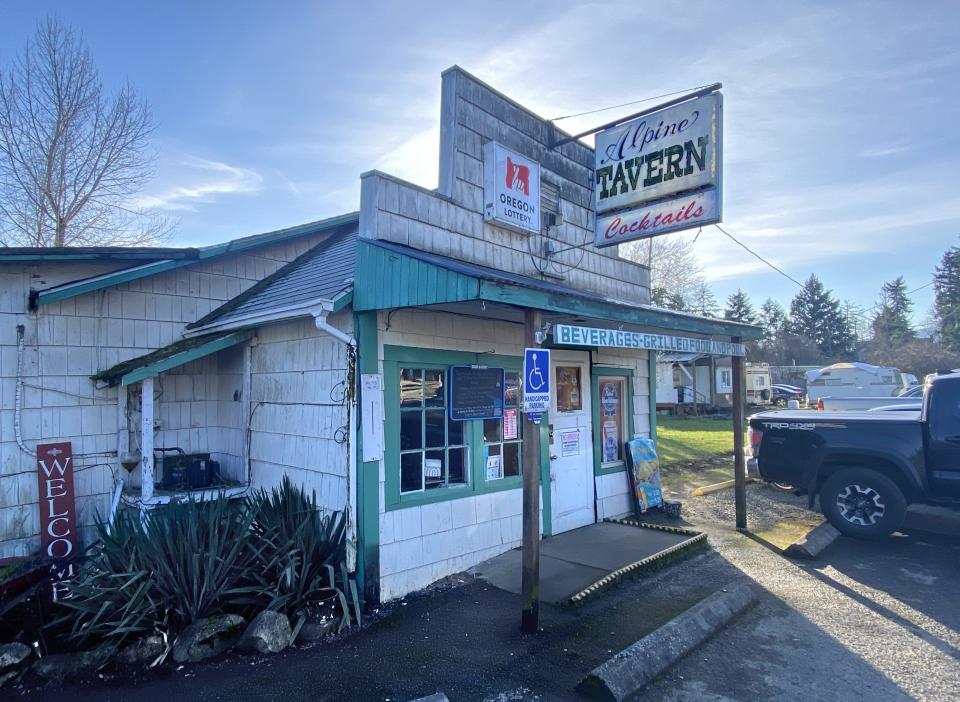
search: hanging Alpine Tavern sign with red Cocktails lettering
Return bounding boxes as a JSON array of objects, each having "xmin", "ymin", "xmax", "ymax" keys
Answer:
[{"xmin": 594, "ymin": 92, "xmax": 723, "ymax": 247}]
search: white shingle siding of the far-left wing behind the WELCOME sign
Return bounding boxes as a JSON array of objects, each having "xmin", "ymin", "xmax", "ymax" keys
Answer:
[{"xmin": 0, "ymin": 236, "xmax": 330, "ymax": 557}]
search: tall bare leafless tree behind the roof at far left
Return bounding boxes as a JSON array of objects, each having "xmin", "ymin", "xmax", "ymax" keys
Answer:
[{"xmin": 0, "ymin": 18, "xmax": 171, "ymax": 247}]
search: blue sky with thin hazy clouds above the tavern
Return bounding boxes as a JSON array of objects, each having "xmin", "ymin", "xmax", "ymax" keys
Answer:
[{"xmin": 0, "ymin": 0, "xmax": 960, "ymax": 320}]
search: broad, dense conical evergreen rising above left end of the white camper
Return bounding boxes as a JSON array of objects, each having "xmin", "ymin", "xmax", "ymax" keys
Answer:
[{"xmin": 788, "ymin": 275, "xmax": 854, "ymax": 359}]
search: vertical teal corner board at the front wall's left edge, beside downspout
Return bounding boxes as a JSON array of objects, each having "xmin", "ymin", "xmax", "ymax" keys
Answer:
[{"xmin": 354, "ymin": 312, "xmax": 386, "ymax": 602}]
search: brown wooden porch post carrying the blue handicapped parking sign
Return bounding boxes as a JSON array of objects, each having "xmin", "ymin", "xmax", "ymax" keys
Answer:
[{"xmin": 520, "ymin": 309, "xmax": 540, "ymax": 634}]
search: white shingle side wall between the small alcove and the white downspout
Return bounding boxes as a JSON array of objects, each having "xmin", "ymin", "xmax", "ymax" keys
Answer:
[{"xmin": 250, "ymin": 313, "xmax": 352, "ymax": 510}]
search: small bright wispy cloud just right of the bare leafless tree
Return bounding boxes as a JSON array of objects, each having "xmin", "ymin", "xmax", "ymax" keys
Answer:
[{"xmin": 134, "ymin": 156, "xmax": 263, "ymax": 211}]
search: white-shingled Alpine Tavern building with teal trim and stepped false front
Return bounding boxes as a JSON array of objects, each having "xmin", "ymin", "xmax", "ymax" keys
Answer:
[{"xmin": 0, "ymin": 67, "xmax": 757, "ymax": 601}]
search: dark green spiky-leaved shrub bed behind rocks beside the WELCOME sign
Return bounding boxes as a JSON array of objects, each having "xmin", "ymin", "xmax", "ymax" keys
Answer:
[{"xmin": 50, "ymin": 477, "xmax": 360, "ymax": 645}]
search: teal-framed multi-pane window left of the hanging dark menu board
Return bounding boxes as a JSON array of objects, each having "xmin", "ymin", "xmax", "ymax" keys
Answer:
[{"xmin": 400, "ymin": 368, "xmax": 470, "ymax": 494}]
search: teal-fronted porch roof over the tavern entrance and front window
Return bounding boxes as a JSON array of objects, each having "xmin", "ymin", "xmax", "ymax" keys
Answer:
[{"xmin": 353, "ymin": 239, "xmax": 762, "ymax": 340}]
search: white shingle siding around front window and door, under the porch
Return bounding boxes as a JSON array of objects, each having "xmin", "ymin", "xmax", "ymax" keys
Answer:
[{"xmin": 378, "ymin": 310, "xmax": 649, "ymax": 601}]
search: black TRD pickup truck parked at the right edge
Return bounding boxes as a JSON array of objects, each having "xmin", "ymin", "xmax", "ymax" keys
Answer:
[{"xmin": 749, "ymin": 373, "xmax": 960, "ymax": 539}]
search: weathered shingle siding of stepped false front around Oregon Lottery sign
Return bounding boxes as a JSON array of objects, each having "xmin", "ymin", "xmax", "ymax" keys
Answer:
[{"xmin": 360, "ymin": 69, "xmax": 650, "ymax": 303}]
